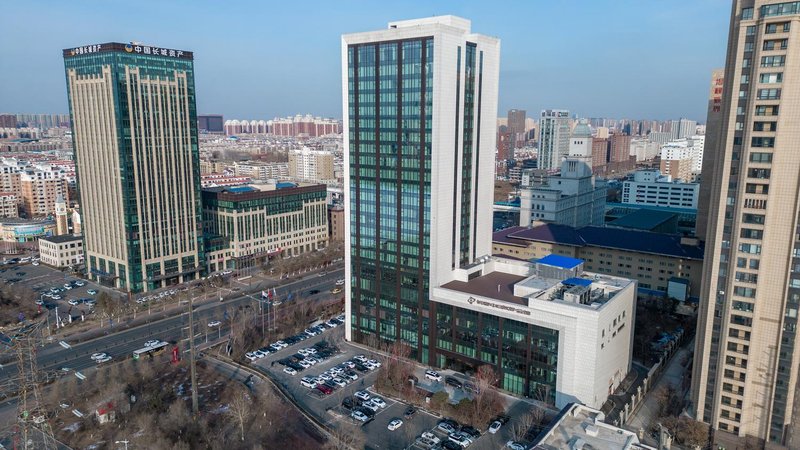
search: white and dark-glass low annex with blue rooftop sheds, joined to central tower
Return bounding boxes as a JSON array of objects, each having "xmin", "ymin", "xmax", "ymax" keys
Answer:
[{"xmin": 431, "ymin": 255, "xmax": 636, "ymax": 408}]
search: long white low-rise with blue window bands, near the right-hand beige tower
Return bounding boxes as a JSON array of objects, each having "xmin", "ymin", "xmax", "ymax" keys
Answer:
[{"xmin": 622, "ymin": 169, "xmax": 700, "ymax": 209}]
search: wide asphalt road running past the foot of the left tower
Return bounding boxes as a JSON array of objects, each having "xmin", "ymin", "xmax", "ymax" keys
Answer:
[{"xmin": 0, "ymin": 269, "xmax": 344, "ymax": 392}]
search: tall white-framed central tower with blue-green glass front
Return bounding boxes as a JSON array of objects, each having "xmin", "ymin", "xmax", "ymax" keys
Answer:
[{"xmin": 342, "ymin": 16, "xmax": 500, "ymax": 363}]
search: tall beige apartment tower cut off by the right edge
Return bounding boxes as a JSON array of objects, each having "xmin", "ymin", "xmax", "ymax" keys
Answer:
[{"xmin": 692, "ymin": 0, "xmax": 800, "ymax": 448}]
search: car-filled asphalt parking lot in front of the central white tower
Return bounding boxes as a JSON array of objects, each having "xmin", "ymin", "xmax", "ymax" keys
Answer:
[{"xmin": 251, "ymin": 326, "xmax": 529, "ymax": 450}]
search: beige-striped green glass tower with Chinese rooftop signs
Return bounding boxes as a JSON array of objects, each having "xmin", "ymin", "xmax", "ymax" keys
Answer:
[{"xmin": 64, "ymin": 43, "xmax": 205, "ymax": 292}]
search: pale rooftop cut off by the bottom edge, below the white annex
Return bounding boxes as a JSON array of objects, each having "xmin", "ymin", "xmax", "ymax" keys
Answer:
[{"xmin": 532, "ymin": 403, "xmax": 655, "ymax": 450}]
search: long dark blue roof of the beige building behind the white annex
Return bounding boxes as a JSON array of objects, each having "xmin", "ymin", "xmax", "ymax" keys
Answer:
[{"xmin": 492, "ymin": 223, "xmax": 703, "ymax": 260}]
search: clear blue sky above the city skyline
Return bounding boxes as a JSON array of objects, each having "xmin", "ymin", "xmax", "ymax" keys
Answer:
[{"xmin": 0, "ymin": 0, "xmax": 731, "ymax": 122}]
